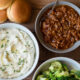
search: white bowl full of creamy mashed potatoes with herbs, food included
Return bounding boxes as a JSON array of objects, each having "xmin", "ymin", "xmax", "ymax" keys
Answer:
[{"xmin": 0, "ymin": 23, "xmax": 39, "ymax": 80}]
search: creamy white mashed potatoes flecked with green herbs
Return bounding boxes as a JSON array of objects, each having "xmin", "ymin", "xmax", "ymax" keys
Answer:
[{"xmin": 0, "ymin": 28, "xmax": 35, "ymax": 79}]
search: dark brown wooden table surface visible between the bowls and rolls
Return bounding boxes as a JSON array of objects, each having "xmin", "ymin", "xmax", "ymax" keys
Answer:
[{"xmin": 23, "ymin": 0, "xmax": 80, "ymax": 80}]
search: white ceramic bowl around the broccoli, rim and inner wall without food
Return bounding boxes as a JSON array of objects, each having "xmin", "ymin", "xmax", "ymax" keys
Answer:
[{"xmin": 32, "ymin": 57, "xmax": 80, "ymax": 80}]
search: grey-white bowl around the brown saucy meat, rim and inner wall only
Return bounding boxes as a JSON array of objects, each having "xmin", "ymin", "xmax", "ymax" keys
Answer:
[{"xmin": 35, "ymin": 1, "xmax": 80, "ymax": 53}]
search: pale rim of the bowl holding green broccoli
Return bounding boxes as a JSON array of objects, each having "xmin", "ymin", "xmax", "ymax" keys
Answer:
[{"xmin": 32, "ymin": 57, "xmax": 80, "ymax": 80}]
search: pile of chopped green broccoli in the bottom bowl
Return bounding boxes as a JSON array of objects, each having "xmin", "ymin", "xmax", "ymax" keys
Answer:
[{"xmin": 36, "ymin": 61, "xmax": 80, "ymax": 80}]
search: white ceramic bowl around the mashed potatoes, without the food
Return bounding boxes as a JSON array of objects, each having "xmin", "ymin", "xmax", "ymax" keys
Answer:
[{"xmin": 0, "ymin": 23, "xmax": 39, "ymax": 80}]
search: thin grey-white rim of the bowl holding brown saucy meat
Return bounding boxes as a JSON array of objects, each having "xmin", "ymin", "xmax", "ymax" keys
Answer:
[{"xmin": 35, "ymin": 1, "xmax": 80, "ymax": 53}]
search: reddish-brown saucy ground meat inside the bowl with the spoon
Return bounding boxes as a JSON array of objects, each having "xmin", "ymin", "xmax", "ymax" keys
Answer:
[{"xmin": 41, "ymin": 5, "xmax": 80, "ymax": 49}]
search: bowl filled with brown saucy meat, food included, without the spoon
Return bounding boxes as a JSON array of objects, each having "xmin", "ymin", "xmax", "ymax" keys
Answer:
[{"xmin": 35, "ymin": 1, "xmax": 80, "ymax": 53}]
